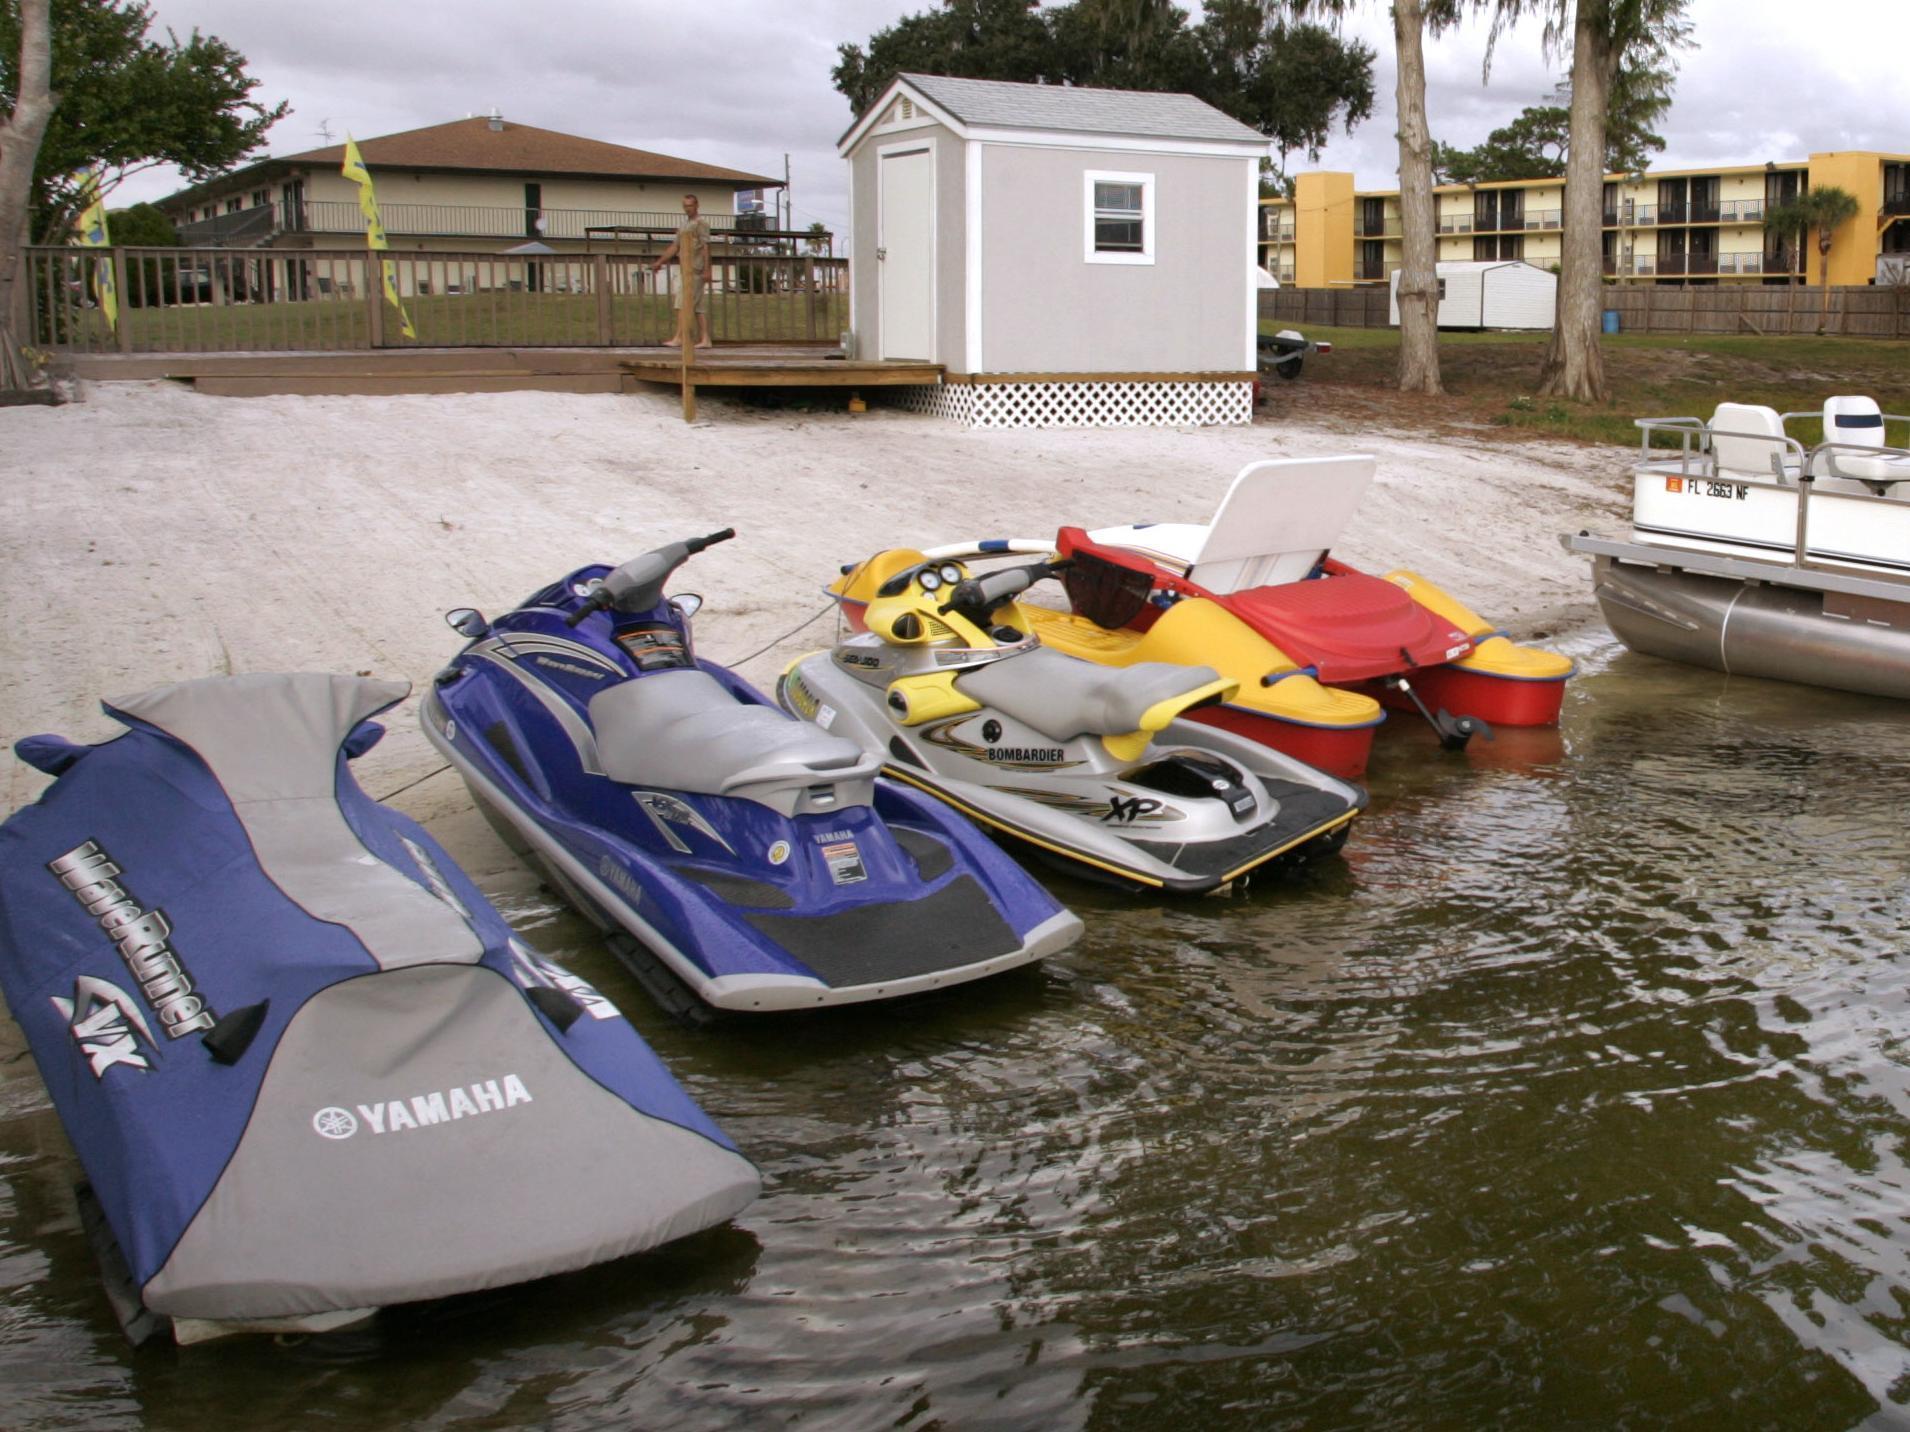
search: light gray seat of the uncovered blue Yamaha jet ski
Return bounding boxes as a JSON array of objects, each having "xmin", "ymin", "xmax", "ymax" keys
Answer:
[{"xmin": 590, "ymin": 668, "xmax": 881, "ymax": 815}]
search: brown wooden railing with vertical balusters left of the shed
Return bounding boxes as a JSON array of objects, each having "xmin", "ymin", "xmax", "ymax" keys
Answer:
[{"xmin": 21, "ymin": 248, "xmax": 848, "ymax": 353}]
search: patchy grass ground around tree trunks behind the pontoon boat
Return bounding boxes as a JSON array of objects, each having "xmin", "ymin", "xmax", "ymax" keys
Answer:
[{"xmin": 1261, "ymin": 321, "xmax": 1910, "ymax": 445}]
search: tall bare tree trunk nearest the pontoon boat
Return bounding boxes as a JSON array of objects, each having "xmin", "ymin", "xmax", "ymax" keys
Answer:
[{"xmin": 1539, "ymin": 0, "xmax": 1618, "ymax": 403}]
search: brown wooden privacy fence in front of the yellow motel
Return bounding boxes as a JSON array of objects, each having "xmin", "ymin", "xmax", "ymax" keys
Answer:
[{"xmin": 1261, "ymin": 284, "xmax": 1910, "ymax": 338}]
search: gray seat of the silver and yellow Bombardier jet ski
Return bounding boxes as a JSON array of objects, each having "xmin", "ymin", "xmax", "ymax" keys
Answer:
[{"xmin": 955, "ymin": 647, "xmax": 1220, "ymax": 741}]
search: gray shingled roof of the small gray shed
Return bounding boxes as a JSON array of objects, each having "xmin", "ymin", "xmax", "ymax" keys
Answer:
[{"xmin": 896, "ymin": 74, "xmax": 1266, "ymax": 143}]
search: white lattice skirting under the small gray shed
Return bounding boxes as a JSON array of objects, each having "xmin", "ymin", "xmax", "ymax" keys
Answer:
[{"xmin": 886, "ymin": 382, "xmax": 1253, "ymax": 428}]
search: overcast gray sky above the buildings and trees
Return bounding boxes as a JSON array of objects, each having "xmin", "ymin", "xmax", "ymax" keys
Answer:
[{"xmin": 113, "ymin": 0, "xmax": 1910, "ymax": 233}]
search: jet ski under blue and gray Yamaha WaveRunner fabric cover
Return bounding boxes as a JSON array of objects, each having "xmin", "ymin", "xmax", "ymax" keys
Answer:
[{"xmin": 0, "ymin": 676, "xmax": 758, "ymax": 1342}]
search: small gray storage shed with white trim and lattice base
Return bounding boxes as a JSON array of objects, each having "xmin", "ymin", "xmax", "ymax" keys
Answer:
[{"xmin": 838, "ymin": 74, "xmax": 1268, "ymax": 426}]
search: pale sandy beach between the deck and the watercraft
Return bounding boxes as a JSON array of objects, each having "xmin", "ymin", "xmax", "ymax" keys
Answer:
[{"xmin": 0, "ymin": 382, "xmax": 1624, "ymax": 821}]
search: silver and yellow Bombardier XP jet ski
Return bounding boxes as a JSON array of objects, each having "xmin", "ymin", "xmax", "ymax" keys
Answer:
[{"xmin": 777, "ymin": 550, "xmax": 1366, "ymax": 894}]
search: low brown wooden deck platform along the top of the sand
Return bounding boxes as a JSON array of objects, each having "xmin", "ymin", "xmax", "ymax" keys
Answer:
[{"xmin": 63, "ymin": 344, "xmax": 944, "ymax": 397}]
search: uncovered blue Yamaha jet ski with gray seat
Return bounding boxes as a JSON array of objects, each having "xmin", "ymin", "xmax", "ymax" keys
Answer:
[{"xmin": 422, "ymin": 531, "xmax": 1081, "ymax": 1018}]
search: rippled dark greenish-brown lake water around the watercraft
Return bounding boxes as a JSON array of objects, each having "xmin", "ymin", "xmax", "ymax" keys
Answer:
[{"xmin": 0, "ymin": 630, "xmax": 1910, "ymax": 1432}]
